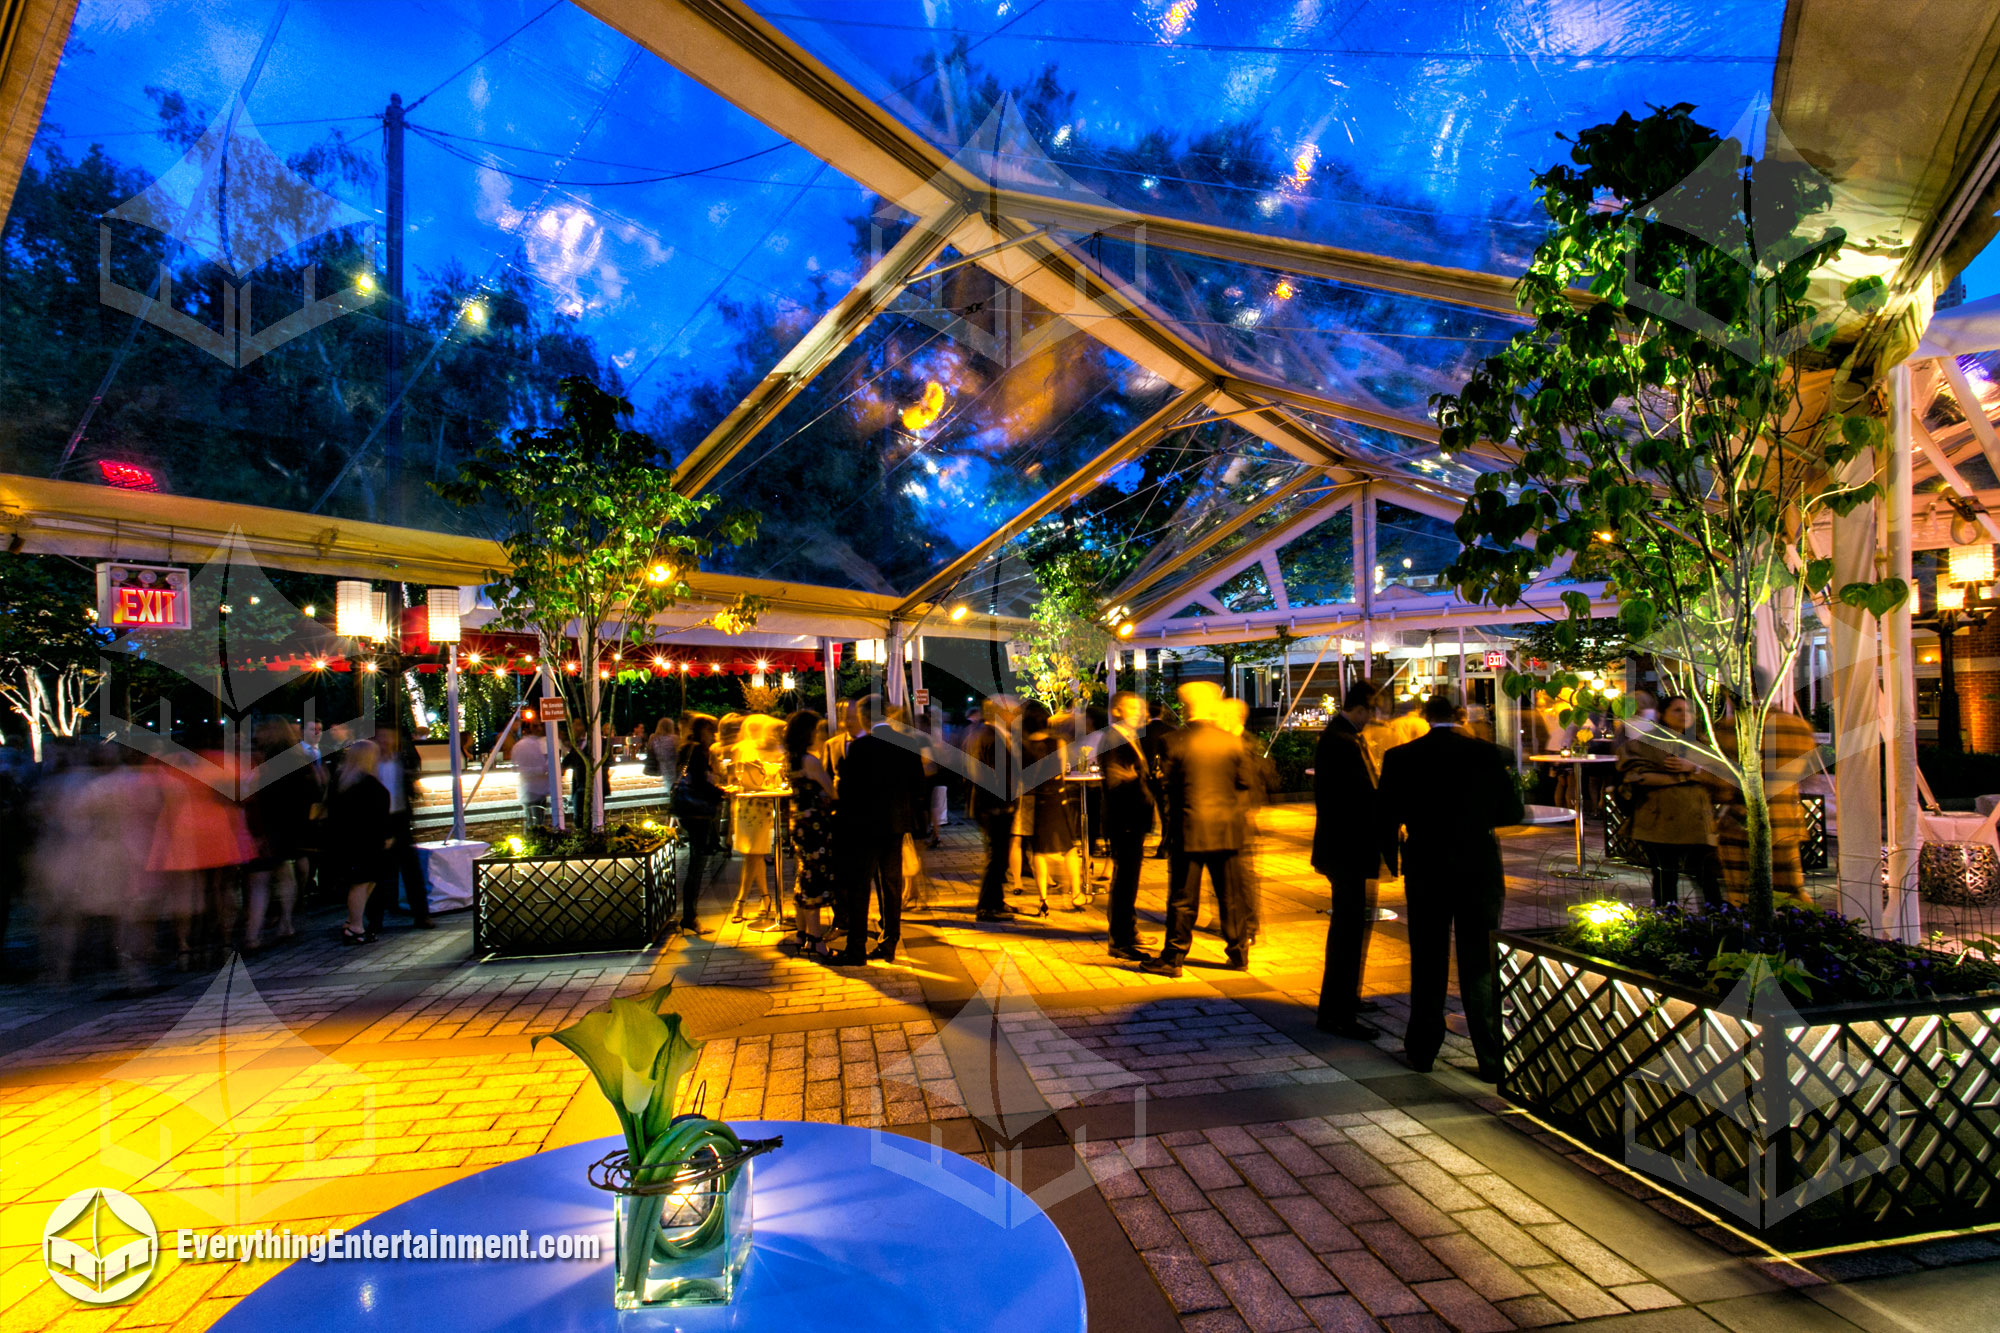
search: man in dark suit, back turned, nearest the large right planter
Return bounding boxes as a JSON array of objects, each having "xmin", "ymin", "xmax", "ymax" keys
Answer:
[{"xmin": 1376, "ymin": 691, "xmax": 1522, "ymax": 1083}]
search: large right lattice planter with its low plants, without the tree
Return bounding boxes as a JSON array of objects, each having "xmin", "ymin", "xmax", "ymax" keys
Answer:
[{"xmin": 1494, "ymin": 903, "xmax": 2000, "ymax": 1247}]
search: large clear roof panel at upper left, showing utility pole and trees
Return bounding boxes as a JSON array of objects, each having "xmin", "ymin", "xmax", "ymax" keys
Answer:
[{"xmin": 0, "ymin": 0, "xmax": 906, "ymax": 530}]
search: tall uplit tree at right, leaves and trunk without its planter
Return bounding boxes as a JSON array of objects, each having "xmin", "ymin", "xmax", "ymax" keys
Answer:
[{"xmin": 1432, "ymin": 104, "xmax": 1906, "ymax": 921}]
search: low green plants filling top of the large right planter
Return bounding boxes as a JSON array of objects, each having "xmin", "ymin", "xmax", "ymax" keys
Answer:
[{"xmin": 1552, "ymin": 901, "xmax": 2000, "ymax": 1003}]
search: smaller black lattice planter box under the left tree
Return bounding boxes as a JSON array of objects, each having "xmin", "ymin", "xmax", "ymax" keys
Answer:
[{"xmin": 472, "ymin": 843, "xmax": 680, "ymax": 957}]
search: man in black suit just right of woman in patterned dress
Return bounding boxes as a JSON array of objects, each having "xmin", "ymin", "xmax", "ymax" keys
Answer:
[{"xmin": 828, "ymin": 695, "xmax": 930, "ymax": 967}]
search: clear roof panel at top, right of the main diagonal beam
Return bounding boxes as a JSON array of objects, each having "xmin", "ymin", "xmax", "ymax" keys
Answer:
[{"xmin": 760, "ymin": 0, "xmax": 1784, "ymax": 272}]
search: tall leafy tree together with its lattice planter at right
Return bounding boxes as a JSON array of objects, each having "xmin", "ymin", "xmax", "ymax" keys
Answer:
[{"xmin": 1432, "ymin": 104, "xmax": 2000, "ymax": 1241}]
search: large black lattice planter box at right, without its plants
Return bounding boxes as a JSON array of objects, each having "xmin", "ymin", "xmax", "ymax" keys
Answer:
[{"xmin": 1494, "ymin": 931, "xmax": 2000, "ymax": 1249}]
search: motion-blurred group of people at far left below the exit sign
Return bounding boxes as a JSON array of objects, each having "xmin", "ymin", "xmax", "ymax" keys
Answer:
[{"xmin": 0, "ymin": 719, "xmax": 432, "ymax": 991}]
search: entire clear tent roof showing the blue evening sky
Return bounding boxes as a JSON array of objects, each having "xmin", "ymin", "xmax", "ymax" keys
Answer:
[{"xmin": 0, "ymin": 0, "xmax": 1872, "ymax": 632}]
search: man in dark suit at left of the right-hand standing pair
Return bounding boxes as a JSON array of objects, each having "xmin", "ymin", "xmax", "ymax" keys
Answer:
[{"xmin": 1312, "ymin": 681, "xmax": 1382, "ymax": 1041}]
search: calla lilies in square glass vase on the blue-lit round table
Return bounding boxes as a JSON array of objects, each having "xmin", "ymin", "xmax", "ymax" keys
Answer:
[{"xmin": 532, "ymin": 983, "xmax": 782, "ymax": 1309}]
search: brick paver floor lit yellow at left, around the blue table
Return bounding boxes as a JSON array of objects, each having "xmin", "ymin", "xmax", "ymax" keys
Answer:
[{"xmin": 0, "ymin": 807, "xmax": 1976, "ymax": 1333}]
